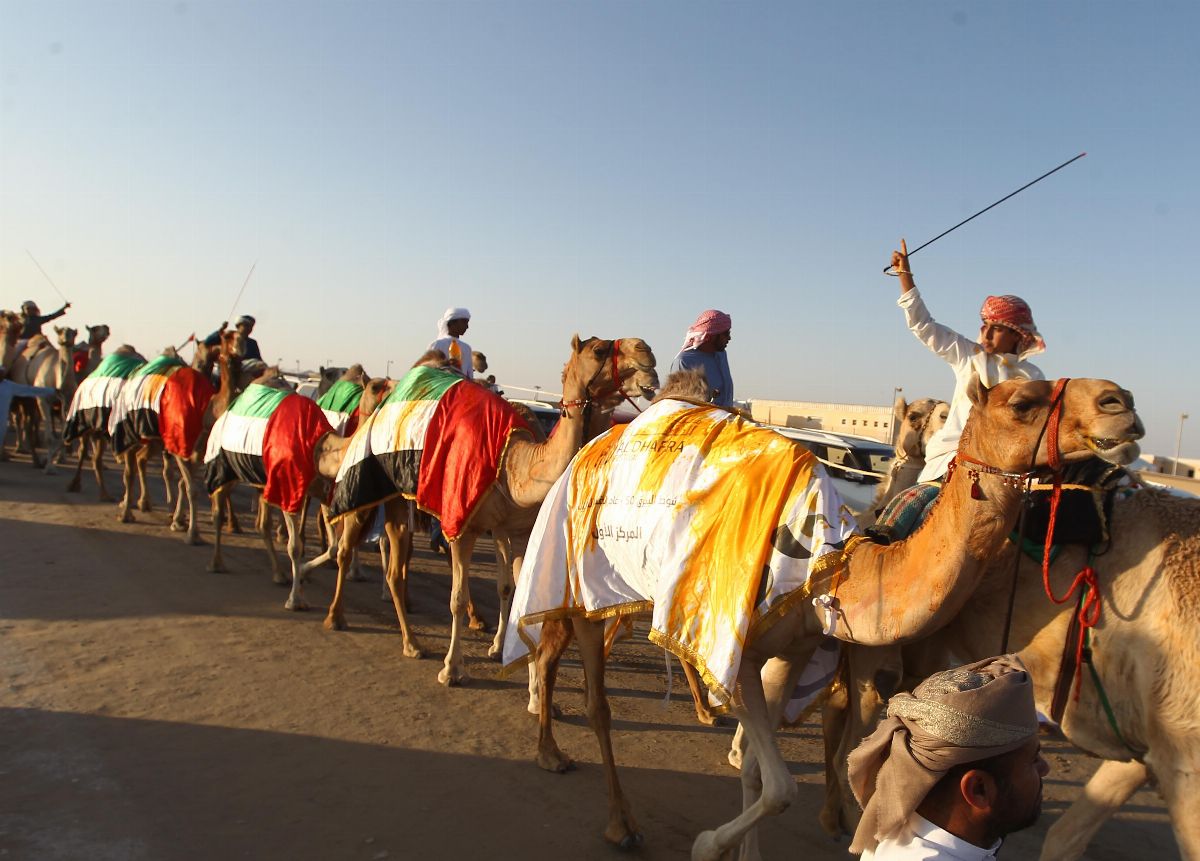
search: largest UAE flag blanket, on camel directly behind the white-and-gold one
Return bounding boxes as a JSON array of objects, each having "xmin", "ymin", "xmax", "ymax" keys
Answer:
[{"xmin": 331, "ymin": 367, "xmax": 529, "ymax": 538}]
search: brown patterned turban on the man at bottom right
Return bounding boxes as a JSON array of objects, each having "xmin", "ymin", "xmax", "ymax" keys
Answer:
[{"xmin": 850, "ymin": 655, "xmax": 1038, "ymax": 853}]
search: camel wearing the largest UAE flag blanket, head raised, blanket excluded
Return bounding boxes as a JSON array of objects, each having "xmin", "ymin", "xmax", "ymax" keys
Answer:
[{"xmin": 325, "ymin": 335, "xmax": 659, "ymax": 686}]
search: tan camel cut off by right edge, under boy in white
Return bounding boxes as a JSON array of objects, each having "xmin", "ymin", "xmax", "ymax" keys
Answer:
[{"xmin": 832, "ymin": 489, "xmax": 1200, "ymax": 861}]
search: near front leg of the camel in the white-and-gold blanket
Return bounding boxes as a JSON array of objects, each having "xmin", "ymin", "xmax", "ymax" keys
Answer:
[{"xmin": 691, "ymin": 656, "xmax": 803, "ymax": 861}]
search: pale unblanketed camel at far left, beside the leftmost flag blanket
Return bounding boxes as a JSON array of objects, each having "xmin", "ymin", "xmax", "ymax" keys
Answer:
[{"xmin": 10, "ymin": 326, "xmax": 78, "ymax": 475}]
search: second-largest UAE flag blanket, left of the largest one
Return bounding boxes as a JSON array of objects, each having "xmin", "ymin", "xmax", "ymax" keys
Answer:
[{"xmin": 204, "ymin": 383, "xmax": 334, "ymax": 513}]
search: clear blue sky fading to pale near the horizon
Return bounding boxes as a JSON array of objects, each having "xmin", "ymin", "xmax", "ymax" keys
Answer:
[{"xmin": 0, "ymin": 0, "xmax": 1200, "ymax": 457}]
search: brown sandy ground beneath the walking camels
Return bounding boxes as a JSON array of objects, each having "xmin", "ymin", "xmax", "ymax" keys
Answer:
[{"xmin": 0, "ymin": 448, "xmax": 1178, "ymax": 861}]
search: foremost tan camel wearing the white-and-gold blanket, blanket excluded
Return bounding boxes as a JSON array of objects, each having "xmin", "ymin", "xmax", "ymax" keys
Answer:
[{"xmin": 522, "ymin": 380, "xmax": 1144, "ymax": 861}]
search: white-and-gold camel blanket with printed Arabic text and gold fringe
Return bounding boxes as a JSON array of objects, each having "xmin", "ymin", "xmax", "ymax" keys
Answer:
[{"xmin": 504, "ymin": 401, "xmax": 854, "ymax": 706}]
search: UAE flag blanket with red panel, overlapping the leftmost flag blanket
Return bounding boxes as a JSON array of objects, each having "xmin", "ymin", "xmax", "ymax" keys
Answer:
[{"xmin": 108, "ymin": 356, "xmax": 216, "ymax": 457}]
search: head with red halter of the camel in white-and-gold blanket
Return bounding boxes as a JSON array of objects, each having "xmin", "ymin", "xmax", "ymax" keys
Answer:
[{"xmin": 959, "ymin": 378, "xmax": 1145, "ymax": 472}]
